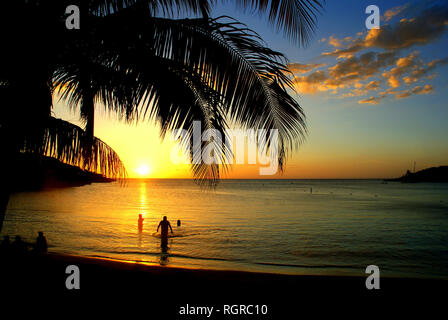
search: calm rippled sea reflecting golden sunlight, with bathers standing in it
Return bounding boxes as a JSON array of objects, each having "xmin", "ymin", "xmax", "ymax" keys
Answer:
[{"xmin": 2, "ymin": 180, "xmax": 448, "ymax": 278}]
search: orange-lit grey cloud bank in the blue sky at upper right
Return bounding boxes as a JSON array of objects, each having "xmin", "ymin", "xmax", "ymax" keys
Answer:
[{"xmin": 289, "ymin": 5, "xmax": 448, "ymax": 104}]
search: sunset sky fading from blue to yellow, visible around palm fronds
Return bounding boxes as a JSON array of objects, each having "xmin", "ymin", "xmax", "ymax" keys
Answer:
[{"xmin": 54, "ymin": 0, "xmax": 448, "ymax": 179}]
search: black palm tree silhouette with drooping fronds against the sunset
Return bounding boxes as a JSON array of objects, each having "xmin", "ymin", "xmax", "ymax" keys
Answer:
[{"xmin": 0, "ymin": 0, "xmax": 323, "ymax": 230}]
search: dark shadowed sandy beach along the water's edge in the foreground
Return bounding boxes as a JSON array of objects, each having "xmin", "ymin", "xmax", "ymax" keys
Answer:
[{"xmin": 1, "ymin": 253, "xmax": 447, "ymax": 319}]
